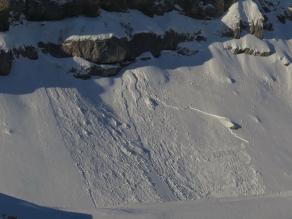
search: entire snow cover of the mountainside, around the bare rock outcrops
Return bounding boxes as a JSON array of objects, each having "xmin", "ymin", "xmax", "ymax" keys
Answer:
[{"xmin": 0, "ymin": 0, "xmax": 292, "ymax": 219}]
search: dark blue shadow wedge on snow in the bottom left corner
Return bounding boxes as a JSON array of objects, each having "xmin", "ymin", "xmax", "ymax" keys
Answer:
[{"xmin": 0, "ymin": 193, "xmax": 92, "ymax": 219}]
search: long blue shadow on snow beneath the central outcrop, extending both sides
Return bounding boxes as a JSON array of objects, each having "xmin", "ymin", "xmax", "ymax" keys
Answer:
[{"xmin": 0, "ymin": 42, "xmax": 213, "ymax": 96}]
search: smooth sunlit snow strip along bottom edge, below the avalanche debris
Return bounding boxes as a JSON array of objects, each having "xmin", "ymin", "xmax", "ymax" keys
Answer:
[{"xmin": 84, "ymin": 196, "xmax": 292, "ymax": 219}]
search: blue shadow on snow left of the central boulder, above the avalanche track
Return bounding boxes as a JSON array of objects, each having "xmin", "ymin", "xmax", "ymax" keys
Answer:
[{"xmin": 0, "ymin": 55, "xmax": 103, "ymax": 102}]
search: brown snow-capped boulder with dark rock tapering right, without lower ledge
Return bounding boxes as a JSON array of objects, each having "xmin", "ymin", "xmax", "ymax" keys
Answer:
[{"xmin": 62, "ymin": 31, "xmax": 194, "ymax": 64}]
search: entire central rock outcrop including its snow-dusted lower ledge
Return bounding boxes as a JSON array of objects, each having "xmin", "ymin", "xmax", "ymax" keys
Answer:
[{"xmin": 44, "ymin": 31, "xmax": 196, "ymax": 79}]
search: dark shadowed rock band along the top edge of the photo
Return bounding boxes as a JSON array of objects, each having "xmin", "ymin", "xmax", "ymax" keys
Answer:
[{"xmin": 4, "ymin": 0, "xmax": 242, "ymax": 31}]
